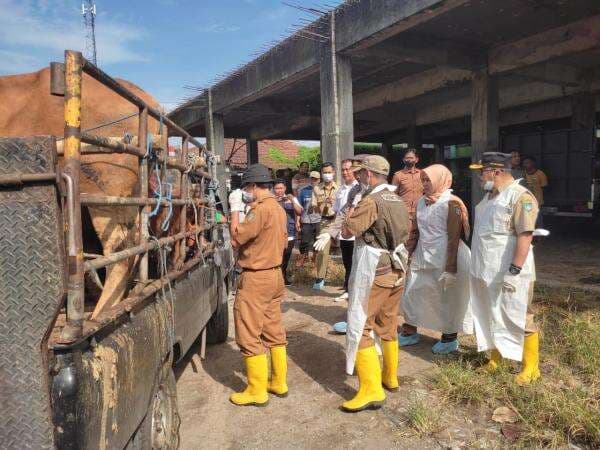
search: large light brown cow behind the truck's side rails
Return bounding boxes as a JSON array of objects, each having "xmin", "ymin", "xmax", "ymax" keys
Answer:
[{"xmin": 0, "ymin": 69, "xmax": 158, "ymax": 317}]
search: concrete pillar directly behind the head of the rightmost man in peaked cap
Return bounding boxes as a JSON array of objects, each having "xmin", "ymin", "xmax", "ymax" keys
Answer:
[{"xmin": 471, "ymin": 71, "xmax": 499, "ymax": 210}]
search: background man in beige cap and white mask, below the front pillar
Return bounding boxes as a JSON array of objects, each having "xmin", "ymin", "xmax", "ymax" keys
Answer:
[{"xmin": 311, "ymin": 163, "xmax": 338, "ymax": 290}]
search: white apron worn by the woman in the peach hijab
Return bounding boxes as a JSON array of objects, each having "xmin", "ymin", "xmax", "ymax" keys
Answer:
[{"xmin": 402, "ymin": 189, "xmax": 473, "ymax": 334}]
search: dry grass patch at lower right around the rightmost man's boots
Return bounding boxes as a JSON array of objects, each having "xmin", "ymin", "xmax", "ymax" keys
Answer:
[{"xmin": 433, "ymin": 290, "xmax": 600, "ymax": 448}]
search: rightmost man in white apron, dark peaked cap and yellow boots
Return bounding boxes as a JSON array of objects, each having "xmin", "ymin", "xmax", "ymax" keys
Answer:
[{"xmin": 471, "ymin": 152, "xmax": 540, "ymax": 384}]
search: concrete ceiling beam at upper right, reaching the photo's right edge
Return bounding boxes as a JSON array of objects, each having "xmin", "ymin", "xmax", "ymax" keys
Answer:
[{"xmin": 488, "ymin": 15, "xmax": 600, "ymax": 74}]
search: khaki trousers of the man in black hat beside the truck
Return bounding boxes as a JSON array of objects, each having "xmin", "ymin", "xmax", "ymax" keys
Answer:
[{"xmin": 233, "ymin": 267, "xmax": 287, "ymax": 356}]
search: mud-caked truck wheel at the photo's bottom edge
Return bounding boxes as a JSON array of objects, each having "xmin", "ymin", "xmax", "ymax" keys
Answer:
[{"xmin": 126, "ymin": 367, "xmax": 181, "ymax": 450}]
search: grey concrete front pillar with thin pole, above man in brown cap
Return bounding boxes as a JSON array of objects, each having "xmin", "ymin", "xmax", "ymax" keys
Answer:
[{"xmin": 320, "ymin": 14, "xmax": 354, "ymax": 182}]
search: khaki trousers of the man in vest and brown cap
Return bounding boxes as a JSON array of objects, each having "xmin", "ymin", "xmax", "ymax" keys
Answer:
[{"xmin": 358, "ymin": 271, "xmax": 404, "ymax": 350}]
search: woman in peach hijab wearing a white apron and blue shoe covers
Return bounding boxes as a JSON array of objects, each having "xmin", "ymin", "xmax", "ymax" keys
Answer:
[{"xmin": 398, "ymin": 164, "xmax": 472, "ymax": 354}]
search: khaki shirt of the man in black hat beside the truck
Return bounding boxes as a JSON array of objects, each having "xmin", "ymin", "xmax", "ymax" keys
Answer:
[{"xmin": 232, "ymin": 192, "xmax": 287, "ymax": 270}]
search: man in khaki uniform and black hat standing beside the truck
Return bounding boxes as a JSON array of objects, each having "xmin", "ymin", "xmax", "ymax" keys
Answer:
[{"xmin": 230, "ymin": 164, "xmax": 288, "ymax": 406}]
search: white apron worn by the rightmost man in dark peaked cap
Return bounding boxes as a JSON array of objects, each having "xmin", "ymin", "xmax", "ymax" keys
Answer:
[{"xmin": 471, "ymin": 180, "xmax": 535, "ymax": 361}]
